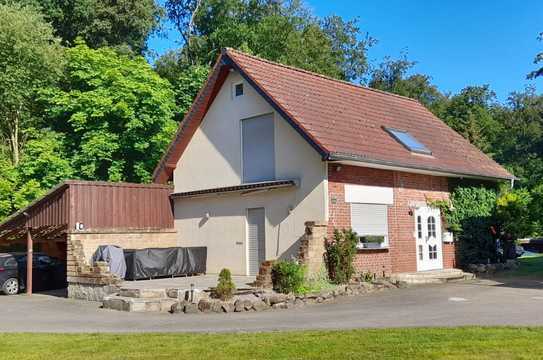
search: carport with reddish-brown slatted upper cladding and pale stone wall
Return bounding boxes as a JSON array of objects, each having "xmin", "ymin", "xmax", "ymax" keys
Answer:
[{"xmin": 0, "ymin": 180, "xmax": 176, "ymax": 294}]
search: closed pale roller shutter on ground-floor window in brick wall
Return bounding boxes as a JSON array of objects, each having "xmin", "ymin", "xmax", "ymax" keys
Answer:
[{"xmin": 351, "ymin": 203, "xmax": 388, "ymax": 236}]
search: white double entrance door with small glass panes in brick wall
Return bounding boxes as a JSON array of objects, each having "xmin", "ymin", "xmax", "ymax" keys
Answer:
[{"xmin": 415, "ymin": 206, "xmax": 443, "ymax": 271}]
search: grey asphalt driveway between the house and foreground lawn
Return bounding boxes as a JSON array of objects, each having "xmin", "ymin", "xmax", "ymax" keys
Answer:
[{"xmin": 0, "ymin": 280, "xmax": 543, "ymax": 332}]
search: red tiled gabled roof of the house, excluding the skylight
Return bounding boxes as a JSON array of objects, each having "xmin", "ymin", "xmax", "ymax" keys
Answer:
[{"xmin": 154, "ymin": 49, "xmax": 514, "ymax": 183}]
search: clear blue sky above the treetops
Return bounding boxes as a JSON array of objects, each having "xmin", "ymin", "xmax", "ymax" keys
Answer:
[{"xmin": 149, "ymin": 0, "xmax": 543, "ymax": 101}]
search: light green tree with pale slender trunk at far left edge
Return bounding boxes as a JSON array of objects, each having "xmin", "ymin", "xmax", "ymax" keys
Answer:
[{"xmin": 0, "ymin": 4, "xmax": 63, "ymax": 165}]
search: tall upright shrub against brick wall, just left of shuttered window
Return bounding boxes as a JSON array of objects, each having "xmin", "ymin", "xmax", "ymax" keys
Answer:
[{"xmin": 326, "ymin": 229, "xmax": 358, "ymax": 284}]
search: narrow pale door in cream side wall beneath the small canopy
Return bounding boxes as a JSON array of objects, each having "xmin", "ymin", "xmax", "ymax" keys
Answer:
[{"xmin": 247, "ymin": 208, "xmax": 266, "ymax": 276}]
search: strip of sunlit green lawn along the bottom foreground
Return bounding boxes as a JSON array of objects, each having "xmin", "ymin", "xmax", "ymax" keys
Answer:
[{"xmin": 0, "ymin": 330, "xmax": 543, "ymax": 360}]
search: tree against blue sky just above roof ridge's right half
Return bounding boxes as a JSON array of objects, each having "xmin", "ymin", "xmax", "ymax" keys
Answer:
[{"xmin": 368, "ymin": 55, "xmax": 446, "ymax": 113}]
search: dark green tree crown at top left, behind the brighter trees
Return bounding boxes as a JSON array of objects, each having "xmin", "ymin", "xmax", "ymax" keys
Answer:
[{"xmin": 17, "ymin": 0, "xmax": 163, "ymax": 54}]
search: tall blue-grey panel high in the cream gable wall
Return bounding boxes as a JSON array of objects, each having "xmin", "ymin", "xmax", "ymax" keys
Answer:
[{"xmin": 241, "ymin": 114, "xmax": 275, "ymax": 183}]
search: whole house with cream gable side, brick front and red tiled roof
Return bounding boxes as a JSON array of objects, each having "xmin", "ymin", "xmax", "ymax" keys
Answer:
[{"xmin": 154, "ymin": 49, "xmax": 514, "ymax": 275}]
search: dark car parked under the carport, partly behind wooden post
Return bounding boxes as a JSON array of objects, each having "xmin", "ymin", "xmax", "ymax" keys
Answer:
[{"xmin": 0, "ymin": 253, "xmax": 67, "ymax": 295}]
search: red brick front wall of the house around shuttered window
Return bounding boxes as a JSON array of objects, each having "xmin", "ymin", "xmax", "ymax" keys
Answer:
[{"xmin": 328, "ymin": 165, "xmax": 454, "ymax": 276}]
